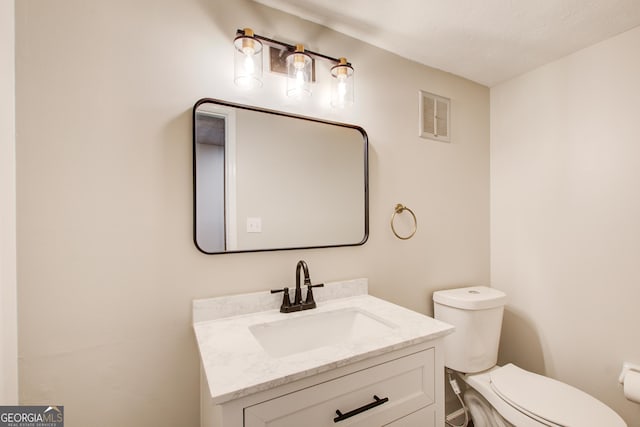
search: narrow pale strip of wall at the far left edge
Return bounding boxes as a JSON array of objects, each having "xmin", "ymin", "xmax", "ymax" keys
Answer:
[{"xmin": 0, "ymin": 0, "xmax": 18, "ymax": 405}]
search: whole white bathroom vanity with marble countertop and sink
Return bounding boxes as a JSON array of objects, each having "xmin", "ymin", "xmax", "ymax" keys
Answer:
[{"xmin": 193, "ymin": 279, "xmax": 453, "ymax": 427}]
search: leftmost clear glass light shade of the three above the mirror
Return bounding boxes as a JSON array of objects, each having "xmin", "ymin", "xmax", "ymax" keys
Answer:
[{"xmin": 233, "ymin": 30, "xmax": 262, "ymax": 88}]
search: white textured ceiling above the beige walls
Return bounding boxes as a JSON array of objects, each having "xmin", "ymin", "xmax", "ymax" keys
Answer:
[{"xmin": 256, "ymin": 0, "xmax": 640, "ymax": 86}]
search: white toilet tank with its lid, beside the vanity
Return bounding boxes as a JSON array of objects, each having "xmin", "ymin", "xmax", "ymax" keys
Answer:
[{"xmin": 433, "ymin": 286, "xmax": 507, "ymax": 373}]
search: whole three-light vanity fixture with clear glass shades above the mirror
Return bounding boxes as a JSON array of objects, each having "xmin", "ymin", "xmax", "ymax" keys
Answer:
[{"xmin": 233, "ymin": 28, "xmax": 354, "ymax": 108}]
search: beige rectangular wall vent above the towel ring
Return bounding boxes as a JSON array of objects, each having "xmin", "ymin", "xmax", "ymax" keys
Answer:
[{"xmin": 419, "ymin": 90, "xmax": 451, "ymax": 142}]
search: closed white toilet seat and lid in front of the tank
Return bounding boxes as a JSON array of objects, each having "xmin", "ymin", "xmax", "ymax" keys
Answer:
[{"xmin": 488, "ymin": 364, "xmax": 626, "ymax": 427}]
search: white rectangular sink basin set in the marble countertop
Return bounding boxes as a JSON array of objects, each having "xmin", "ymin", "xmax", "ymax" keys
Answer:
[{"xmin": 249, "ymin": 308, "xmax": 396, "ymax": 357}]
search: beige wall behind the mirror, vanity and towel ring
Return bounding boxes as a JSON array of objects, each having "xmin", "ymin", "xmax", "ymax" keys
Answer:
[{"xmin": 16, "ymin": 0, "xmax": 489, "ymax": 427}]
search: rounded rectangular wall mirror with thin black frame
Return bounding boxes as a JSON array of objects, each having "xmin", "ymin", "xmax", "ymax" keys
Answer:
[{"xmin": 193, "ymin": 99, "xmax": 369, "ymax": 254}]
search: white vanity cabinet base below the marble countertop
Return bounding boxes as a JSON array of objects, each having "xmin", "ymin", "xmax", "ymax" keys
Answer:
[{"xmin": 201, "ymin": 340, "xmax": 444, "ymax": 427}]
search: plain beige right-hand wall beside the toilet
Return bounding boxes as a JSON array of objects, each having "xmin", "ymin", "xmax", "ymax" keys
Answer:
[{"xmin": 491, "ymin": 28, "xmax": 640, "ymax": 427}]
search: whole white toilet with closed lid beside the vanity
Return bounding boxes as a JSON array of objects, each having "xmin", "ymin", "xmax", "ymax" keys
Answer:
[{"xmin": 433, "ymin": 286, "xmax": 626, "ymax": 427}]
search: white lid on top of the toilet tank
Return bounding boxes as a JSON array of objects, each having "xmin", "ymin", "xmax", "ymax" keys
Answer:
[{"xmin": 433, "ymin": 286, "xmax": 507, "ymax": 310}]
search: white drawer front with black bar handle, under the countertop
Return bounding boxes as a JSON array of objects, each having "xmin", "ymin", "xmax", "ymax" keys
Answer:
[{"xmin": 244, "ymin": 348, "xmax": 435, "ymax": 427}]
